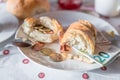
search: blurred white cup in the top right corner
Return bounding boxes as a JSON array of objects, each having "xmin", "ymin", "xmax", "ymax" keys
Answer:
[{"xmin": 95, "ymin": 0, "xmax": 120, "ymax": 17}]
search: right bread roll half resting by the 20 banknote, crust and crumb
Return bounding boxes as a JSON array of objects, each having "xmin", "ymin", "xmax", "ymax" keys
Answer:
[{"xmin": 60, "ymin": 20, "xmax": 97, "ymax": 55}]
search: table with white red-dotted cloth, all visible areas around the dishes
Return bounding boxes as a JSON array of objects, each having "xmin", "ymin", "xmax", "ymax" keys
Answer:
[{"xmin": 0, "ymin": 0, "xmax": 120, "ymax": 80}]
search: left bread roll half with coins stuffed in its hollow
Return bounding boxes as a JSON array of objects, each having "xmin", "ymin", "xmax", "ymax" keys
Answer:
[{"xmin": 22, "ymin": 16, "xmax": 63, "ymax": 43}]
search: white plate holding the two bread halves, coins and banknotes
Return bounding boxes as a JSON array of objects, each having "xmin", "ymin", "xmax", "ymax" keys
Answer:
[{"xmin": 16, "ymin": 11, "xmax": 118, "ymax": 71}]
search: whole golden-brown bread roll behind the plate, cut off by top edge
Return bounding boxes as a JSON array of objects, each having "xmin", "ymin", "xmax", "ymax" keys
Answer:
[{"xmin": 7, "ymin": 0, "xmax": 50, "ymax": 19}]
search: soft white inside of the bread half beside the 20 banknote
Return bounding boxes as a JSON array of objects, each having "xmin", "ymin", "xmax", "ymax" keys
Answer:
[{"xmin": 64, "ymin": 32, "xmax": 92, "ymax": 53}]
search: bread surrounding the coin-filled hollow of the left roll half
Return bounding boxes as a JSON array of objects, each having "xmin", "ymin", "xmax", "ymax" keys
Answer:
[{"xmin": 22, "ymin": 16, "xmax": 63, "ymax": 43}]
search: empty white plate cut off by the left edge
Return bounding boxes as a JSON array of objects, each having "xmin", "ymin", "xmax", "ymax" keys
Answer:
[{"xmin": 0, "ymin": 5, "xmax": 19, "ymax": 43}]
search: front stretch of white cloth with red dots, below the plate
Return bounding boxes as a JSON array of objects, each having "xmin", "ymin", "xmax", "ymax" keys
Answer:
[{"xmin": 0, "ymin": 47, "xmax": 120, "ymax": 80}]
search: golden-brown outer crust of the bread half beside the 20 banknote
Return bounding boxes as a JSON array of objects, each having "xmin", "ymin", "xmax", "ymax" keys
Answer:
[{"xmin": 60, "ymin": 21, "xmax": 97, "ymax": 55}]
